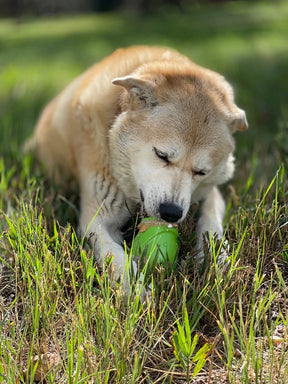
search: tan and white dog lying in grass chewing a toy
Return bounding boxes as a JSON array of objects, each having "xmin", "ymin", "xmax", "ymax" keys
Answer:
[{"xmin": 34, "ymin": 46, "xmax": 247, "ymax": 285}]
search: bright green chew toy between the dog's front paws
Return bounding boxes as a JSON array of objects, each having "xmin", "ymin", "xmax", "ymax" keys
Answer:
[{"xmin": 132, "ymin": 217, "xmax": 179, "ymax": 273}]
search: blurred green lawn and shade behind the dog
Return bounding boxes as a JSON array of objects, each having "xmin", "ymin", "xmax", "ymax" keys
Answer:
[{"xmin": 0, "ymin": 0, "xmax": 288, "ymax": 188}]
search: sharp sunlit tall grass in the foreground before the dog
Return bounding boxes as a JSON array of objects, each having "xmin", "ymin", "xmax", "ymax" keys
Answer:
[{"xmin": 0, "ymin": 162, "xmax": 288, "ymax": 383}]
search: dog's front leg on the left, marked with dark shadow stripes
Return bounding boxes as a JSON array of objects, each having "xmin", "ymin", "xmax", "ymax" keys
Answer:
[{"xmin": 80, "ymin": 175, "xmax": 137, "ymax": 291}]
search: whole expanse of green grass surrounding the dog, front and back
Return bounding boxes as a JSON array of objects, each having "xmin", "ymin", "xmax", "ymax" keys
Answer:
[{"xmin": 0, "ymin": 2, "xmax": 288, "ymax": 384}]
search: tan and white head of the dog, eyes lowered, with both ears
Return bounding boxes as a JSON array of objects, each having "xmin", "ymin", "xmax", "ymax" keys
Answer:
[{"xmin": 110, "ymin": 62, "xmax": 247, "ymax": 222}]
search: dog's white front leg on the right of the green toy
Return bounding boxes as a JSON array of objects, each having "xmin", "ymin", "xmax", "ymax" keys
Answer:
[{"xmin": 196, "ymin": 187, "xmax": 227, "ymax": 263}]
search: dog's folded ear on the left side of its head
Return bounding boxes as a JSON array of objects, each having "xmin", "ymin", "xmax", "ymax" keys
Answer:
[{"xmin": 112, "ymin": 76, "xmax": 157, "ymax": 107}]
